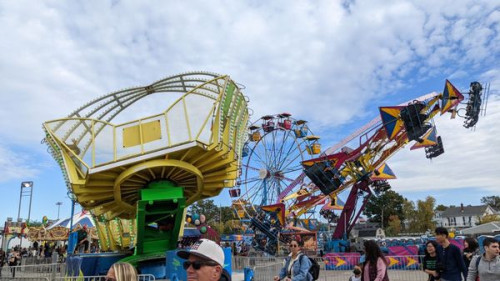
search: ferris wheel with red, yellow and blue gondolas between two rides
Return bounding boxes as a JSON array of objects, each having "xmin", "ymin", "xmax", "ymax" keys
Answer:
[{"xmin": 229, "ymin": 113, "xmax": 321, "ymax": 220}]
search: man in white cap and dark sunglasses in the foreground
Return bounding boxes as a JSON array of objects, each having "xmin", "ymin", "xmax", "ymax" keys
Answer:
[{"xmin": 177, "ymin": 239, "xmax": 231, "ymax": 281}]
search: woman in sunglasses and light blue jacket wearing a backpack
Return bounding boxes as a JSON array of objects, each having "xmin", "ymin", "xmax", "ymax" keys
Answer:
[{"xmin": 274, "ymin": 240, "xmax": 312, "ymax": 281}]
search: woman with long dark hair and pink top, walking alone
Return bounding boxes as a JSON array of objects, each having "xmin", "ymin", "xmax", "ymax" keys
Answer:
[{"xmin": 361, "ymin": 240, "xmax": 389, "ymax": 281}]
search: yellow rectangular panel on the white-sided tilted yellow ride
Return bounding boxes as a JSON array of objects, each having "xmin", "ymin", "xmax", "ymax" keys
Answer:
[{"xmin": 123, "ymin": 120, "xmax": 161, "ymax": 148}]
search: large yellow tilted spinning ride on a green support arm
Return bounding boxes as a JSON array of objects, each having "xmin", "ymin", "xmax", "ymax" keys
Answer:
[{"xmin": 43, "ymin": 72, "xmax": 249, "ymax": 267}]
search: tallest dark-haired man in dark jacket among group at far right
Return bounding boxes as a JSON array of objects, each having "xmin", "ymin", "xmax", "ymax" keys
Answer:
[{"xmin": 435, "ymin": 227, "xmax": 467, "ymax": 281}]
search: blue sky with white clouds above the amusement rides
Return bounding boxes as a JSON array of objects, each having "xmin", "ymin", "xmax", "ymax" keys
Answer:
[{"xmin": 0, "ymin": 0, "xmax": 500, "ymax": 221}]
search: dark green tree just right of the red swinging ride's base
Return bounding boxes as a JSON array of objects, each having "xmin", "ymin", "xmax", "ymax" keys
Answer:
[{"xmin": 363, "ymin": 190, "xmax": 405, "ymax": 226}]
